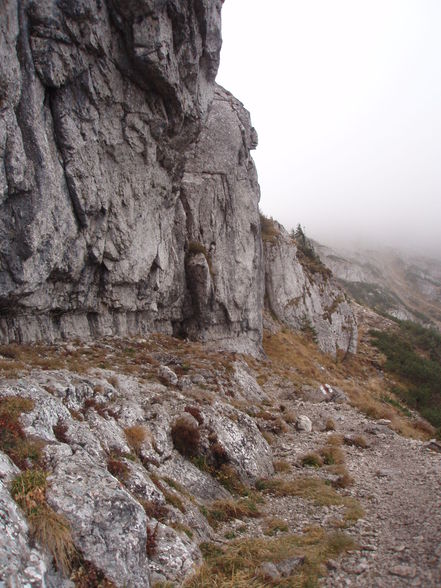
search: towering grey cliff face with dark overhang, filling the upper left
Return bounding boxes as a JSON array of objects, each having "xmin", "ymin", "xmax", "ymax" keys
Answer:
[{"xmin": 0, "ymin": 0, "xmax": 263, "ymax": 352}]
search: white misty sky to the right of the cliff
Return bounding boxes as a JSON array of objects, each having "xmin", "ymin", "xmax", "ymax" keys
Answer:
[{"xmin": 217, "ymin": 0, "xmax": 441, "ymax": 255}]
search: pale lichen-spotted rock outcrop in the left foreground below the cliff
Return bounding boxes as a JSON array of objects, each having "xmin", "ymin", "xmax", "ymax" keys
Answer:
[{"xmin": 0, "ymin": 370, "xmax": 274, "ymax": 587}]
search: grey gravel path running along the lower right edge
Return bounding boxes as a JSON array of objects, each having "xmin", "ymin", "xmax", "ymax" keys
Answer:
[{"xmin": 324, "ymin": 432, "xmax": 441, "ymax": 587}]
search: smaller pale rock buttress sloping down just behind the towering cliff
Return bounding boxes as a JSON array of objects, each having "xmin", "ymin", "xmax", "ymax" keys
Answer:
[{"xmin": 264, "ymin": 224, "xmax": 357, "ymax": 355}]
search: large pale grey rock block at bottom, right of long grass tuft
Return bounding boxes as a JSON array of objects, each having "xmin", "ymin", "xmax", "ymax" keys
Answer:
[{"xmin": 47, "ymin": 447, "xmax": 149, "ymax": 587}]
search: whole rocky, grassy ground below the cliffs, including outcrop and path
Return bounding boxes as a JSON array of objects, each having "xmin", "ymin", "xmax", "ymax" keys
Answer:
[{"xmin": 0, "ymin": 329, "xmax": 441, "ymax": 588}]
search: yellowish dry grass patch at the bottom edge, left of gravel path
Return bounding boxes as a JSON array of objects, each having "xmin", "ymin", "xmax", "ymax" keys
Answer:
[{"xmin": 184, "ymin": 528, "xmax": 355, "ymax": 588}]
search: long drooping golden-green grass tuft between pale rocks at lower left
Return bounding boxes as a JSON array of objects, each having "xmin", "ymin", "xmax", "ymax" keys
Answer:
[{"xmin": 11, "ymin": 469, "xmax": 77, "ymax": 574}]
